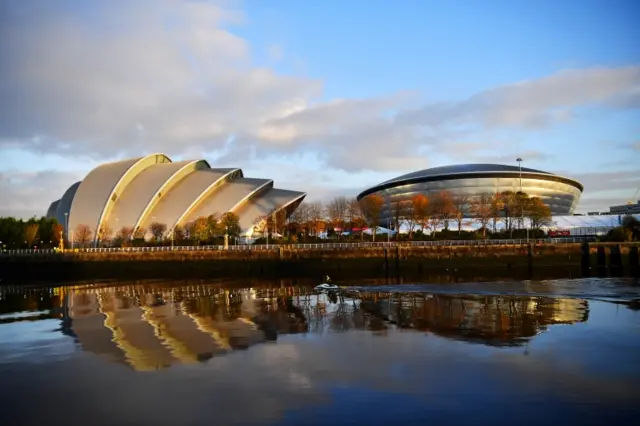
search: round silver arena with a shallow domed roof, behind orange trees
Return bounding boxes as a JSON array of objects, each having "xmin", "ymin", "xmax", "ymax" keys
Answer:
[{"xmin": 357, "ymin": 163, "xmax": 584, "ymax": 226}]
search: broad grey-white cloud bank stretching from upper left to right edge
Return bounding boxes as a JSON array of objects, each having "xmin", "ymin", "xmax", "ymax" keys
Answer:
[{"xmin": 0, "ymin": 0, "xmax": 640, "ymax": 215}]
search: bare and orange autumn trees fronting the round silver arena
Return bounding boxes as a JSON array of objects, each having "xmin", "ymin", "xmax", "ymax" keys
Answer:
[{"xmin": 292, "ymin": 191, "xmax": 552, "ymax": 240}]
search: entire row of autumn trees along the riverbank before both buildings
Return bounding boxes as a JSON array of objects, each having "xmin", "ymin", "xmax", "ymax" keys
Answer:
[{"xmin": 0, "ymin": 191, "xmax": 638, "ymax": 249}]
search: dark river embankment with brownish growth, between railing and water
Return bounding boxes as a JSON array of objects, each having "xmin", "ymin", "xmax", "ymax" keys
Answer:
[{"xmin": 0, "ymin": 243, "xmax": 637, "ymax": 282}]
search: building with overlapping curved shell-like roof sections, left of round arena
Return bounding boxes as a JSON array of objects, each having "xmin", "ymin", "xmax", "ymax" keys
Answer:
[{"xmin": 47, "ymin": 154, "xmax": 307, "ymax": 242}]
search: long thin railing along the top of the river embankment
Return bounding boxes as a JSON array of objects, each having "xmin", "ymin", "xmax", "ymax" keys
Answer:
[{"xmin": 0, "ymin": 237, "xmax": 595, "ymax": 256}]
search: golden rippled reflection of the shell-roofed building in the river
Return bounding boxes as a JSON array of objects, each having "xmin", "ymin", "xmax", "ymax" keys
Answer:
[{"xmin": 68, "ymin": 289, "xmax": 264, "ymax": 371}]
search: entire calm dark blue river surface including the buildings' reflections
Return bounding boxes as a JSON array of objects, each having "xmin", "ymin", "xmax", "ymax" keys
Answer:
[{"xmin": 0, "ymin": 279, "xmax": 640, "ymax": 426}]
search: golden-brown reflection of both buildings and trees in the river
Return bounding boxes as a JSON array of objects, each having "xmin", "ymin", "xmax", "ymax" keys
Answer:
[{"xmin": 0, "ymin": 284, "xmax": 589, "ymax": 371}]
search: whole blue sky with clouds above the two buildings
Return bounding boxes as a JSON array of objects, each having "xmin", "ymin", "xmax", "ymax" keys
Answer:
[{"xmin": 0, "ymin": 0, "xmax": 640, "ymax": 217}]
